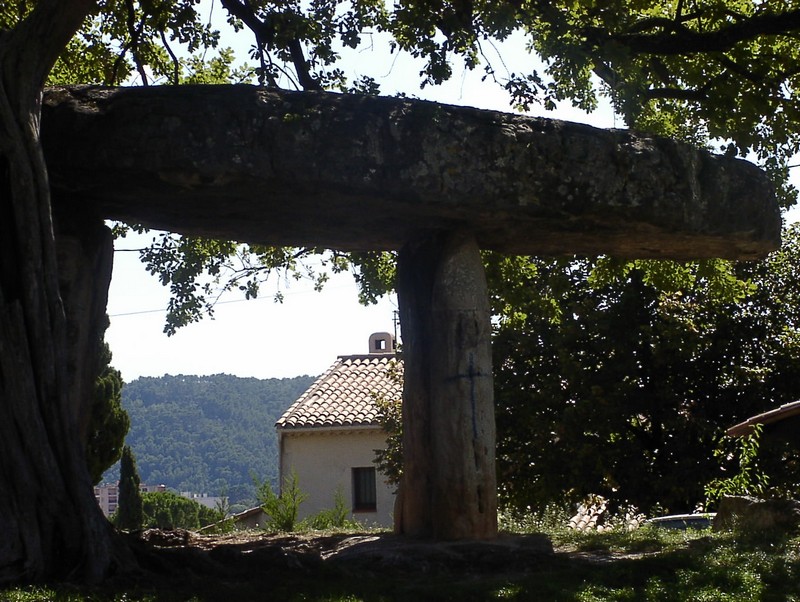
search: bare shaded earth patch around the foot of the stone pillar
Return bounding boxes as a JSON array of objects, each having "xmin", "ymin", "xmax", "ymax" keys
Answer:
[{"xmin": 92, "ymin": 530, "xmax": 642, "ymax": 602}]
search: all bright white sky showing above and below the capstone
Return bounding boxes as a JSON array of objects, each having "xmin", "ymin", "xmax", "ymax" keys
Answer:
[{"xmin": 106, "ymin": 7, "xmax": 796, "ymax": 382}]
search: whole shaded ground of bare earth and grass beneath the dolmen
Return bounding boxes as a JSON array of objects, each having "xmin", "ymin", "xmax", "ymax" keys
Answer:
[{"xmin": 7, "ymin": 524, "xmax": 800, "ymax": 602}]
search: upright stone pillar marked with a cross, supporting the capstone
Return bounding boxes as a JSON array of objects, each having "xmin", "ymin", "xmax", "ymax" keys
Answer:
[{"xmin": 395, "ymin": 233, "xmax": 497, "ymax": 540}]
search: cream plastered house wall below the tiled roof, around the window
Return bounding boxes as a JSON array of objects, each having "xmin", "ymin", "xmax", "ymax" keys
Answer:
[{"xmin": 281, "ymin": 429, "xmax": 395, "ymax": 527}]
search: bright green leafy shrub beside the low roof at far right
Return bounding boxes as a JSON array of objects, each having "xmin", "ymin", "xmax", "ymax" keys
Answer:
[{"xmin": 705, "ymin": 424, "xmax": 769, "ymax": 506}]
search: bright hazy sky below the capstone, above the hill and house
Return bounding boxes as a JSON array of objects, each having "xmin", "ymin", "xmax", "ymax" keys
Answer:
[{"xmin": 107, "ymin": 237, "xmax": 396, "ymax": 381}]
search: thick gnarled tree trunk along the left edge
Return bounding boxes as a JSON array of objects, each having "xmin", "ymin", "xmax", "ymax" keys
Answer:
[{"xmin": 0, "ymin": 0, "xmax": 113, "ymax": 585}]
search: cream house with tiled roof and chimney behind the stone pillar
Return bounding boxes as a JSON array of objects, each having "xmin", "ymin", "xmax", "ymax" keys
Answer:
[{"xmin": 275, "ymin": 332, "xmax": 403, "ymax": 527}]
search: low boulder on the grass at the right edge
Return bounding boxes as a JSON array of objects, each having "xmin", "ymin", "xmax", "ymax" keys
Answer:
[{"xmin": 714, "ymin": 496, "xmax": 800, "ymax": 532}]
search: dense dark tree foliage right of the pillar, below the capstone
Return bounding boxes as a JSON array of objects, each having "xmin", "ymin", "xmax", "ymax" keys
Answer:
[{"xmin": 488, "ymin": 227, "xmax": 800, "ymax": 512}]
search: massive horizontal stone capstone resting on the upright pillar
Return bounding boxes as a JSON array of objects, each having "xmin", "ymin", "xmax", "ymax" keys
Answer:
[{"xmin": 42, "ymin": 86, "xmax": 780, "ymax": 259}]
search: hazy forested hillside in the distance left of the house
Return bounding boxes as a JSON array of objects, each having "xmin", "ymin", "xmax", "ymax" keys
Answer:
[{"xmin": 100, "ymin": 374, "xmax": 314, "ymax": 505}]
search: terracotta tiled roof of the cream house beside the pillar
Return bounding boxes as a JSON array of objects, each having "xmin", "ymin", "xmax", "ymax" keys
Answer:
[{"xmin": 275, "ymin": 353, "xmax": 403, "ymax": 429}]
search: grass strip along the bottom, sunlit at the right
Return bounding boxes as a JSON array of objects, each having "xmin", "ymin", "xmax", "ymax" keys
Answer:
[{"xmin": 0, "ymin": 520, "xmax": 800, "ymax": 602}]
